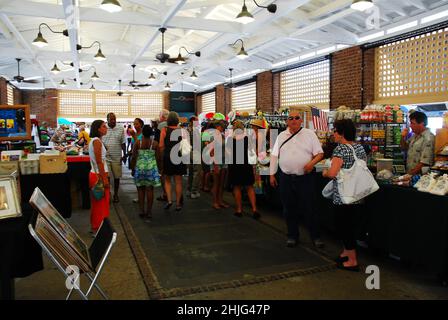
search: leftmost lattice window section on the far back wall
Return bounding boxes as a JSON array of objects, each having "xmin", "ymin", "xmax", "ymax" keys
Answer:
[{"xmin": 58, "ymin": 90, "xmax": 95, "ymax": 117}]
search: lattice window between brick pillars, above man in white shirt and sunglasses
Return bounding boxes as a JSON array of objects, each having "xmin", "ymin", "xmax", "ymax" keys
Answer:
[{"xmin": 280, "ymin": 60, "xmax": 330, "ymax": 109}]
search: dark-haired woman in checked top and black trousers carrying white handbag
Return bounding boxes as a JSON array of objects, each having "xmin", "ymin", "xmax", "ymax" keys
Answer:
[{"xmin": 322, "ymin": 119, "xmax": 367, "ymax": 271}]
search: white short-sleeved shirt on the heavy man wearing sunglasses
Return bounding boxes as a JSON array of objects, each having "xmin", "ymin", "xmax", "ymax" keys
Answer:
[{"xmin": 271, "ymin": 128, "xmax": 324, "ymax": 175}]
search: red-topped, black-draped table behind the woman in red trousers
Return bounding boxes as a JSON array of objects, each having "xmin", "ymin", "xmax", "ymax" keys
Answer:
[{"xmin": 67, "ymin": 155, "xmax": 90, "ymax": 209}]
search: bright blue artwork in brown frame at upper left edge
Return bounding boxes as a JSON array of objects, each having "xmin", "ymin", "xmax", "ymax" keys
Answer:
[{"xmin": 0, "ymin": 105, "xmax": 31, "ymax": 141}]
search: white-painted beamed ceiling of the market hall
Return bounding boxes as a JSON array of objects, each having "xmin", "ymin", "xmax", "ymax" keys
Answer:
[{"xmin": 0, "ymin": 0, "xmax": 448, "ymax": 91}]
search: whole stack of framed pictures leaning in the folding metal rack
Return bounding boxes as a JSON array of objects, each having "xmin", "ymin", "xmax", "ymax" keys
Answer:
[{"xmin": 30, "ymin": 187, "xmax": 93, "ymax": 271}]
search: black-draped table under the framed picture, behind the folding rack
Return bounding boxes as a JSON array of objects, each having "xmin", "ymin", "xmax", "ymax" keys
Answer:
[{"xmin": 0, "ymin": 204, "xmax": 43, "ymax": 300}]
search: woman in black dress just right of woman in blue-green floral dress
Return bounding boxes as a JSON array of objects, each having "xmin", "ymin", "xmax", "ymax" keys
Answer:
[{"xmin": 159, "ymin": 111, "xmax": 188, "ymax": 211}]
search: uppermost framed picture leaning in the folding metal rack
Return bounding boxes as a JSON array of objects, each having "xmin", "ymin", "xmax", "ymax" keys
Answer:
[{"xmin": 30, "ymin": 188, "xmax": 91, "ymax": 268}]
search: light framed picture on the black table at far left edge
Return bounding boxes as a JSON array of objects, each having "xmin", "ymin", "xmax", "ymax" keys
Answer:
[{"xmin": 0, "ymin": 176, "xmax": 22, "ymax": 219}]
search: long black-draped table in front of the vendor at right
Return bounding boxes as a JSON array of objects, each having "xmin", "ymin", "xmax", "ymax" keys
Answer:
[{"xmin": 316, "ymin": 177, "xmax": 448, "ymax": 280}]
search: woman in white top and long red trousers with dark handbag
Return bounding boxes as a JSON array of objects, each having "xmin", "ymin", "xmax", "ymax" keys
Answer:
[{"xmin": 89, "ymin": 120, "xmax": 110, "ymax": 235}]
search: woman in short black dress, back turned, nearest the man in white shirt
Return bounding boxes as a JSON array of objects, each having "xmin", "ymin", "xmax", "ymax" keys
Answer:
[{"xmin": 226, "ymin": 120, "xmax": 260, "ymax": 219}]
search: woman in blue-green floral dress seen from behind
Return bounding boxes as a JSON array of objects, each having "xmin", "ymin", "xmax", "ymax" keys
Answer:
[{"xmin": 131, "ymin": 125, "xmax": 160, "ymax": 222}]
